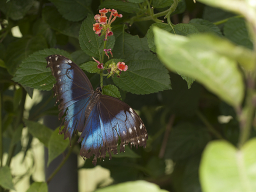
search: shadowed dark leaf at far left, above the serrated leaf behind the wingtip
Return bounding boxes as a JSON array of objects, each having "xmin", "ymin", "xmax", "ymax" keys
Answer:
[{"xmin": 6, "ymin": 36, "xmax": 47, "ymax": 75}]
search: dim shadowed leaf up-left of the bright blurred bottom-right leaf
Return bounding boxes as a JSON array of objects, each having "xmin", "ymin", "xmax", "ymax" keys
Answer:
[{"xmin": 165, "ymin": 123, "xmax": 211, "ymax": 161}]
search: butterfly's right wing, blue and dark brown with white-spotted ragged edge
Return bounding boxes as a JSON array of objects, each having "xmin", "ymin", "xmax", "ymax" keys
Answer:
[{"xmin": 80, "ymin": 95, "xmax": 148, "ymax": 164}]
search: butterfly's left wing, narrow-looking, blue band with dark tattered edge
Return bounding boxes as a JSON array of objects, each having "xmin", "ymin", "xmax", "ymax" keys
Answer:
[{"xmin": 46, "ymin": 55, "xmax": 94, "ymax": 139}]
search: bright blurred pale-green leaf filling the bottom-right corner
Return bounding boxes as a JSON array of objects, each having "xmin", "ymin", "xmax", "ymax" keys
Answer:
[{"xmin": 199, "ymin": 138, "xmax": 256, "ymax": 192}]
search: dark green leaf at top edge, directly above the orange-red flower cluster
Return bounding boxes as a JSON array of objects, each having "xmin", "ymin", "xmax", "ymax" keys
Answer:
[{"xmin": 100, "ymin": 0, "xmax": 140, "ymax": 13}]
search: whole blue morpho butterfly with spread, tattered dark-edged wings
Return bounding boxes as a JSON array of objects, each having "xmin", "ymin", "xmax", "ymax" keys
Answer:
[{"xmin": 46, "ymin": 55, "xmax": 148, "ymax": 165}]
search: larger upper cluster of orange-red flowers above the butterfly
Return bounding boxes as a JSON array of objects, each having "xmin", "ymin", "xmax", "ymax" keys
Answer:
[{"xmin": 93, "ymin": 8, "xmax": 123, "ymax": 41}]
